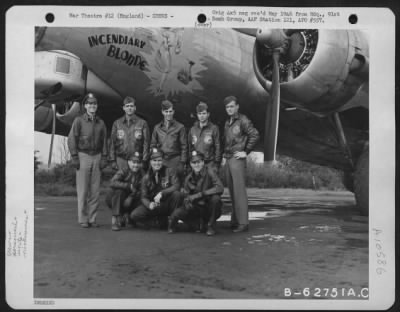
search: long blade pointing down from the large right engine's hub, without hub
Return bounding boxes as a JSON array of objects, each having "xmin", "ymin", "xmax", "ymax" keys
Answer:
[{"xmin": 264, "ymin": 49, "xmax": 280, "ymax": 162}]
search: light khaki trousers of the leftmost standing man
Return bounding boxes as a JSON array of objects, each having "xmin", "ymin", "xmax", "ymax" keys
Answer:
[{"xmin": 76, "ymin": 152, "xmax": 101, "ymax": 223}]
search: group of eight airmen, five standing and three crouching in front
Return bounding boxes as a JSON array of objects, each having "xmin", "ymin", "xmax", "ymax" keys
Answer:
[{"xmin": 68, "ymin": 93, "xmax": 259, "ymax": 236}]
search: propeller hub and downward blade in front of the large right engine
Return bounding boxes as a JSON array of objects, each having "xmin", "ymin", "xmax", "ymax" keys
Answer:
[{"xmin": 256, "ymin": 29, "xmax": 289, "ymax": 162}]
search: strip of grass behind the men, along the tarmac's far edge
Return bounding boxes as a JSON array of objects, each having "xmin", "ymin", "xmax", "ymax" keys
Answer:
[{"xmin": 35, "ymin": 156, "xmax": 345, "ymax": 196}]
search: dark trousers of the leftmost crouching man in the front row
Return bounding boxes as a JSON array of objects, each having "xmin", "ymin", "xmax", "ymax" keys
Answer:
[{"xmin": 106, "ymin": 189, "xmax": 141, "ymax": 216}]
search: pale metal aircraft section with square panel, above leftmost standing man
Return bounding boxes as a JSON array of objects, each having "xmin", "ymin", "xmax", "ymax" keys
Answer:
[{"xmin": 35, "ymin": 50, "xmax": 122, "ymax": 131}]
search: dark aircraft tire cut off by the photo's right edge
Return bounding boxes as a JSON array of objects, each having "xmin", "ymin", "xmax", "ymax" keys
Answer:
[{"xmin": 354, "ymin": 147, "xmax": 369, "ymax": 216}]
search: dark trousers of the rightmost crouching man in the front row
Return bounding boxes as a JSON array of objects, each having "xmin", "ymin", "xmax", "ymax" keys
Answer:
[{"xmin": 171, "ymin": 195, "xmax": 222, "ymax": 227}]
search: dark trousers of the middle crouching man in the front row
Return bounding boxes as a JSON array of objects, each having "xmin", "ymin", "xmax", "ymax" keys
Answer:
[{"xmin": 131, "ymin": 191, "xmax": 182, "ymax": 224}]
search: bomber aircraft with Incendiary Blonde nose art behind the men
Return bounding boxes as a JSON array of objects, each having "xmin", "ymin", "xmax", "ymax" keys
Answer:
[{"xmin": 35, "ymin": 27, "xmax": 369, "ymax": 215}]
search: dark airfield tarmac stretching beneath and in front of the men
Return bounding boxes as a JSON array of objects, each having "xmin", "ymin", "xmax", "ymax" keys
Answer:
[{"xmin": 34, "ymin": 189, "xmax": 368, "ymax": 299}]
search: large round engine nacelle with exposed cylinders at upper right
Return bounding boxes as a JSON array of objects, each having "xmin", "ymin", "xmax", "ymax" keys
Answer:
[{"xmin": 253, "ymin": 29, "xmax": 368, "ymax": 114}]
